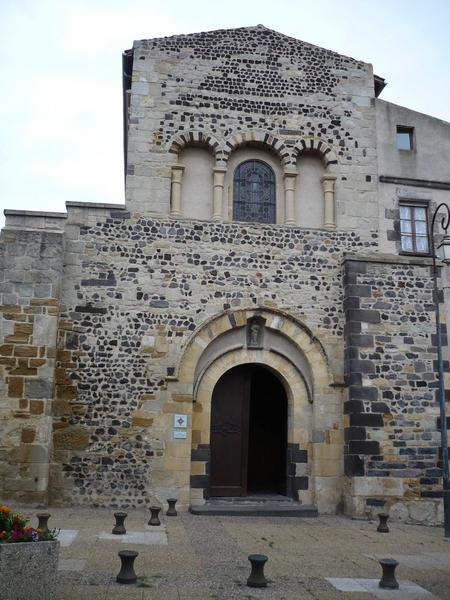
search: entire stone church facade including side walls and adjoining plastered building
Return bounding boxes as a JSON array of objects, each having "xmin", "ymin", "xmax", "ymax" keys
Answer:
[{"xmin": 0, "ymin": 26, "xmax": 450, "ymax": 523}]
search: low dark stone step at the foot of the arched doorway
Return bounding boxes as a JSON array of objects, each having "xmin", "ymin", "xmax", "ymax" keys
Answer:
[{"xmin": 189, "ymin": 499, "xmax": 318, "ymax": 517}]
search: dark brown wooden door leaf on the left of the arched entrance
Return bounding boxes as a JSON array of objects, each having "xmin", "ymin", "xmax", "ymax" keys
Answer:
[{"xmin": 210, "ymin": 367, "xmax": 251, "ymax": 496}]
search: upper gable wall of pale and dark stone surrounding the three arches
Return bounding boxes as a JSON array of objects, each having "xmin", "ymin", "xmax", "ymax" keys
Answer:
[{"xmin": 127, "ymin": 25, "xmax": 378, "ymax": 233}]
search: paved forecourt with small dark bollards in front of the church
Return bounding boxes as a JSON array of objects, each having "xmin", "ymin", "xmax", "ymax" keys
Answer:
[{"xmin": 23, "ymin": 508, "xmax": 450, "ymax": 600}]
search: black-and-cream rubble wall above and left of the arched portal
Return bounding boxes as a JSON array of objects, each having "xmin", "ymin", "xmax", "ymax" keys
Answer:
[{"xmin": 56, "ymin": 218, "xmax": 377, "ymax": 506}]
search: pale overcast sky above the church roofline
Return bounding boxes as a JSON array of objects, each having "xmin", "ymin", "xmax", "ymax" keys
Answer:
[{"xmin": 0, "ymin": 0, "xmax": 450, "ymax": 226}]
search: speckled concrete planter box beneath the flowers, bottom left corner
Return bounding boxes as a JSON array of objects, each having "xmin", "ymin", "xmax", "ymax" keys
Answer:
[{"xmin": 0, "ymin": 540, "xmax": 59, "ymax": 600}]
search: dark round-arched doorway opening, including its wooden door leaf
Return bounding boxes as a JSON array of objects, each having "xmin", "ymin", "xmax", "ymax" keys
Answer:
[{"xmin": 209, "ymin": 364, "xmax": 287, "ymax": 497}]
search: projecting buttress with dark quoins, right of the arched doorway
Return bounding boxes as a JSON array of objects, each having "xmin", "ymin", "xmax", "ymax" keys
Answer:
[{"xmin": 344, "ymin": 258, "xmax": 447, "ymax": 506}]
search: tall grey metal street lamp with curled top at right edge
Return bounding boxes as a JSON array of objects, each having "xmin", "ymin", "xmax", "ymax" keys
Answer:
[{"xmin": 430, "ymin": 203, "xmax": 450, "ymax": 538}]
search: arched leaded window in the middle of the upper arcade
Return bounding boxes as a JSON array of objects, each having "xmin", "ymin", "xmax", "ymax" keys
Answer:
[{"xmin": 233, "ymin": 160, "xmax": 275, "ymax": 223}]
